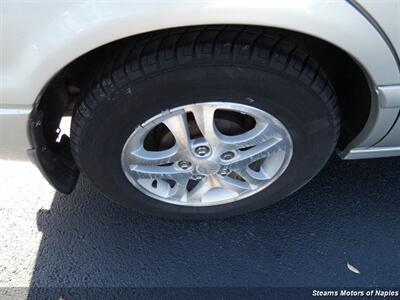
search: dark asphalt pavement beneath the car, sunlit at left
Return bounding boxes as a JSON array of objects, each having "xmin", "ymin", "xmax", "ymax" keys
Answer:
[{"xmin": 0, "ymin": 157, "xmax": 400, "ymax": 293}]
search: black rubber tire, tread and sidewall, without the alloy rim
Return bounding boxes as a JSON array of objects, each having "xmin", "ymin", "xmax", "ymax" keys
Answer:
[{"xmin": 71, "ymin": 26, "xmax": 340, "ymax": 219}]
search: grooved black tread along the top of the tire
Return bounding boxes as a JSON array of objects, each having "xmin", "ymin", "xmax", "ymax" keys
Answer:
[{"xmin": 71, "ymin": 25, "xmax": 340, "ymax": 171}]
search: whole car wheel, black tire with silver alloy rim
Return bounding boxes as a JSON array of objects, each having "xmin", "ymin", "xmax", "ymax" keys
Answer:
[{"xmin": 71, "ymin": 26, "xmax": 340, "ymax": 219}]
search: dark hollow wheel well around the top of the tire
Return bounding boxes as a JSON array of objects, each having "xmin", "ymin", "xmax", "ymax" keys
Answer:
[{"xmin": 31, "ymin": 25, "xmax": 371, "ymax": 191}]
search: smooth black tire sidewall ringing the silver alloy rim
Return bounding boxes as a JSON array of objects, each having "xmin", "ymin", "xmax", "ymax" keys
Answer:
[{"xmin": 79, "ymin": 64, "xmax": 336, "ymax": 219}]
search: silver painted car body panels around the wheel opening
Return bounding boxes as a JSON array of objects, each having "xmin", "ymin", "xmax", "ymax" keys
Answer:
[{"xmin": 0, "ymin": 0, "xmax": 400, "ymax": 160}]
